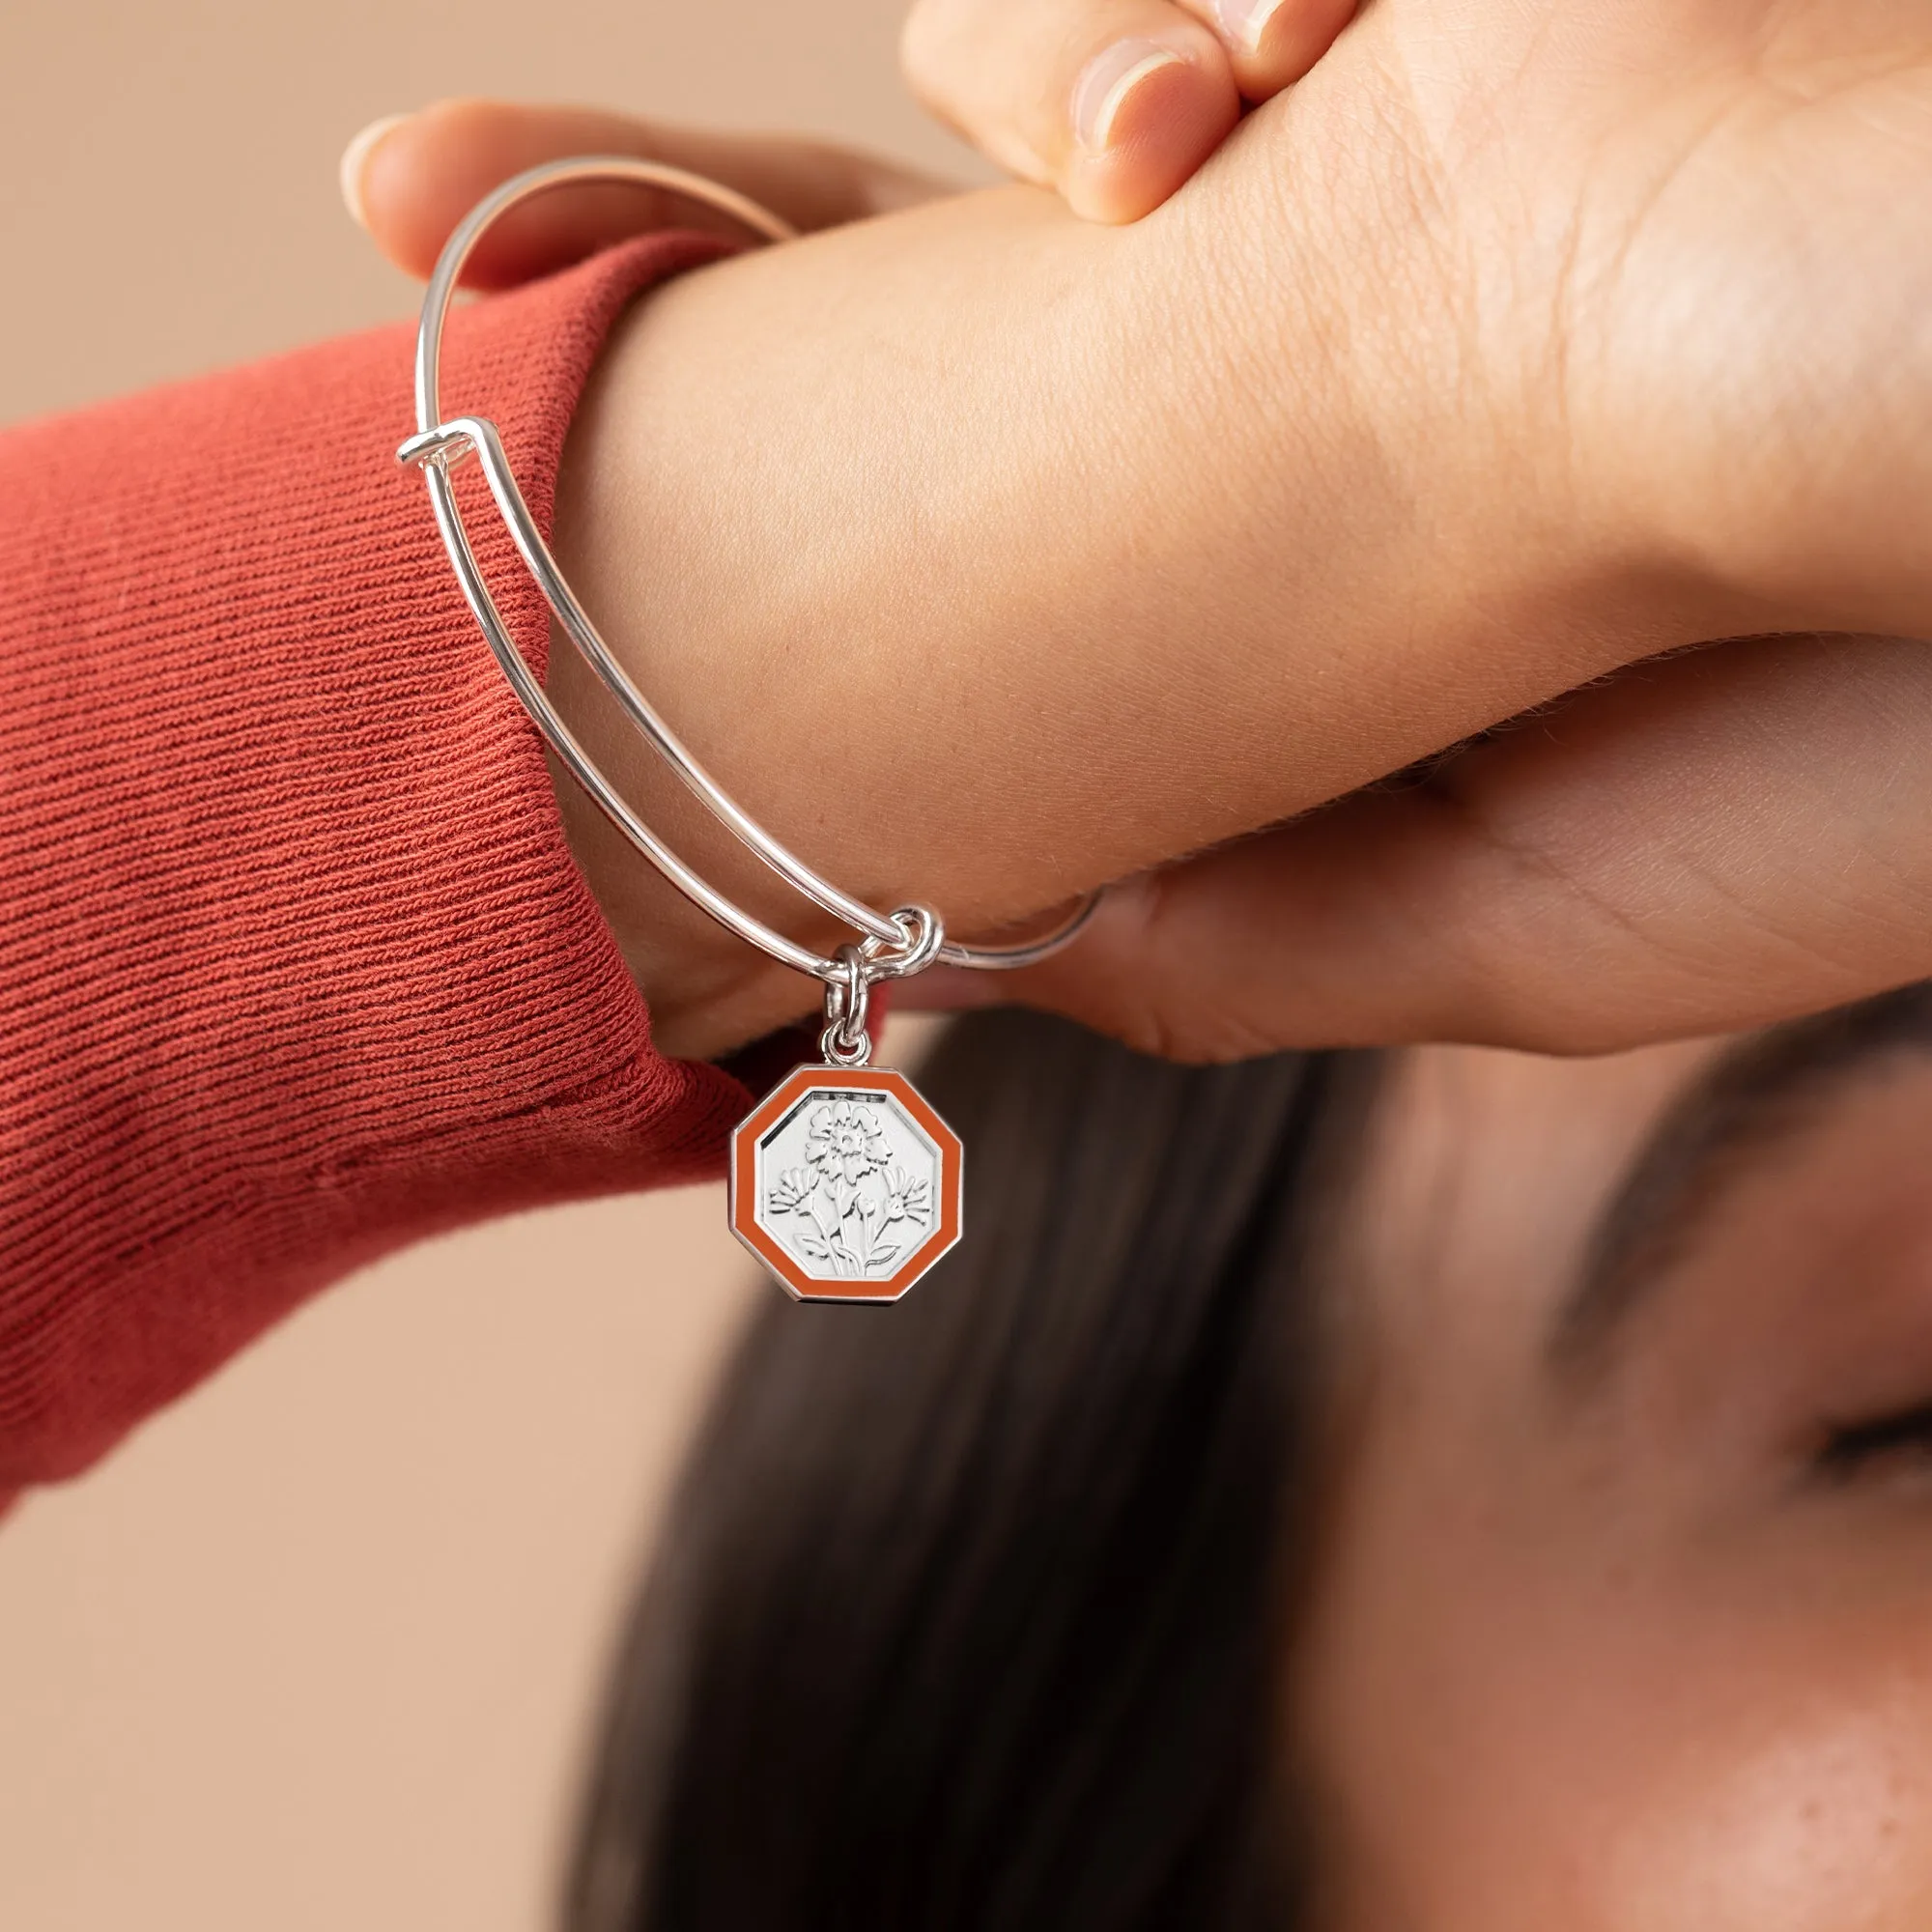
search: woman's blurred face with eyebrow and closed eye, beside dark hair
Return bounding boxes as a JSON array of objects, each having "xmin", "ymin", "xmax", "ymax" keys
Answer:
[{"xmin": 1287, "ymin": 995, "xmax": 1932, "ymax": 1932}]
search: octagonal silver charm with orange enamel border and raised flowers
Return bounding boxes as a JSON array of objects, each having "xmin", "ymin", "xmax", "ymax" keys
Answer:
[{"xmin": 730, "ymin": 1066, "xmax": 964, "ymax": 1302}]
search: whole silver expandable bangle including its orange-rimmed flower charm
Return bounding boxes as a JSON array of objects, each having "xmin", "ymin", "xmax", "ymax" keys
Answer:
[{"xmin": 396, "ymin": 155, "xmax": 1099, "ymax": 1302}]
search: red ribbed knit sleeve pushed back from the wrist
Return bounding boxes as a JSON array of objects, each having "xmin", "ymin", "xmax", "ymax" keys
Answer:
[{"xmin": 0, "ymin": 238, "xmax": 746, "ymax": 1499}]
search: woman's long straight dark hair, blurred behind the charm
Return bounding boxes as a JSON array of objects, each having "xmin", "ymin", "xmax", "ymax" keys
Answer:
[{"xmin": 566, "ymin": 1012, "xmax": 1366, "ymax": 1932}]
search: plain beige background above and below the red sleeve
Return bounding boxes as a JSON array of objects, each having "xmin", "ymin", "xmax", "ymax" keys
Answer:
[{"xmin": 0, "ymin": 0, "xmax": 964, "ymax": 1932}]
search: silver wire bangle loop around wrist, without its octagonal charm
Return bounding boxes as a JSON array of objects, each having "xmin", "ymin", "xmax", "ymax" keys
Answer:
[{"xmin": 396, "ymin": 155, "xmax": 1099, "ymax": 981}]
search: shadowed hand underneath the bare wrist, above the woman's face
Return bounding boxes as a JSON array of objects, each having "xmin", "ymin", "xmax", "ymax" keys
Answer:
[{"xmin": 908, "ymin": 638, "xmax": 1932, "ymax": 1061}]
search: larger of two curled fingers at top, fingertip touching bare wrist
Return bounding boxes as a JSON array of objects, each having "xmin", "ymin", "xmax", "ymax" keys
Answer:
[{"xmin": 900, "ymin": 0, "xmax": 1236, "ymax": 222}]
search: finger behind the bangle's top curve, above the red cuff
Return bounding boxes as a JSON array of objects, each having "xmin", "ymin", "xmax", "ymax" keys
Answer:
[{"xmin": 342, "ymin": 100, "xmax": 941, "ymax": 288}]
